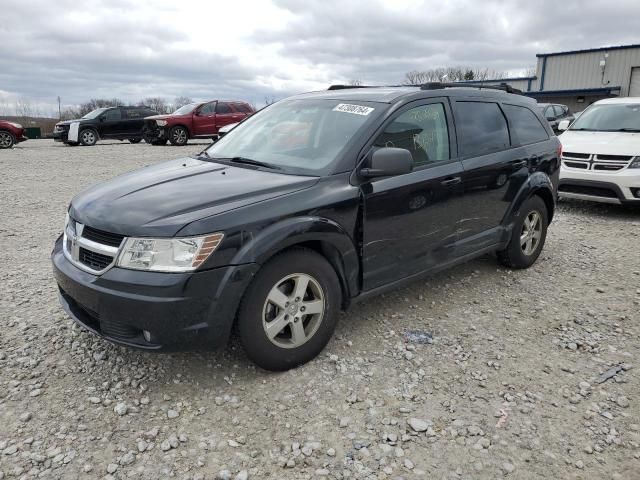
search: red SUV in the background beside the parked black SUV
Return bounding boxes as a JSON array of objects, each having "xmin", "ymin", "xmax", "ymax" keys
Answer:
[{"xmin": 142, "ymin": 100, "xmax": 255, "ymax": 145}]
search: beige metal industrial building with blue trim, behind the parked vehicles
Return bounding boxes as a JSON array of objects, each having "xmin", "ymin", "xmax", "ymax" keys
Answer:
[{"xmin": 465, "ymin": 44, "xmax": 640, "ymax": 112}]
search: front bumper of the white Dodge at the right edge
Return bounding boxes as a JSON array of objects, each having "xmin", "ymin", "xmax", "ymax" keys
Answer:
[{"xmin": 558, "ymin": 165, "xmax": 640, "ymax": 205}]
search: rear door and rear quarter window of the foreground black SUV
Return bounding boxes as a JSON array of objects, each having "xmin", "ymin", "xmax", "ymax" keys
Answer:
[{"xmin": 455, "ymin": 100, "xmax": 549, "ymax": 255}]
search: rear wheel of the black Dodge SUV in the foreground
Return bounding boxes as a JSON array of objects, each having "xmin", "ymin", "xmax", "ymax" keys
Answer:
[{"xmin": 498, "ymin": 195, "xmax": 548, "ymax": 268}]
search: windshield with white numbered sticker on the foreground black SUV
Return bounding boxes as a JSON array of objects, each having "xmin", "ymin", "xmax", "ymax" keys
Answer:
[{"xmin": 206, "ymin": 99, "xmax": 384, "ymax": 175}]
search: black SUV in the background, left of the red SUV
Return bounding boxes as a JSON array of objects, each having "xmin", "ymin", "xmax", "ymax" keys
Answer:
[{"xmin": 53, "ymin": 107, "xmax": 158, "ymax": 146}]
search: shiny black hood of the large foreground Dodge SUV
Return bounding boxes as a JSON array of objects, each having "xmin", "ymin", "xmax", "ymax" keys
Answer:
[{"xmin": 69, "ymin": 158, "xmax": 318, "ymax": 237}]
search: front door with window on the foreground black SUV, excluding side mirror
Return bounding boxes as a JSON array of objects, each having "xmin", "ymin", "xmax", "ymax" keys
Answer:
[{"xmin": 361, "ymin": 99, "xmax": 463, "ymax": 290}]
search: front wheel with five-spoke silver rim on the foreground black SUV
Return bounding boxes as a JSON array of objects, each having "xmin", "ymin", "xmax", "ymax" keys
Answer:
[{"xmin": 238, "ymin": 248, "xmax": 341, "ymax": 371}]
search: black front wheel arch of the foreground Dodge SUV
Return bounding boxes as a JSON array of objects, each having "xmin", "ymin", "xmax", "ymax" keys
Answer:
[{"xmin": 233, "ymin": 217, "xmax": 360, "ymax": 308}]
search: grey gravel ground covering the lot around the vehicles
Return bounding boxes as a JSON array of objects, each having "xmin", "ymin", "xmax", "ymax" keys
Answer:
[{"xmin": 0, "ymin": 140, "xmax": 640, "ymax": 480}]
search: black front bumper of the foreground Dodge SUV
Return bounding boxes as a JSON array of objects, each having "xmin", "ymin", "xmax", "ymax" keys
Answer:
[{"xmin": 51, "ymin": 237, "xmax": 258, "ymax": 350}]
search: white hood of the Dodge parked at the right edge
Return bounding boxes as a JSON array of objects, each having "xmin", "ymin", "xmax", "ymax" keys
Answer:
[{"xmin": 558, "ymin": 130, "xmax": 640, "ymax": 155}]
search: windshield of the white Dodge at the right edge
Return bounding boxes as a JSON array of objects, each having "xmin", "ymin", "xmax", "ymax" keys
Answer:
[{"xmin": 571, "ymin": 103, "xmax": 640, "ymax": 132}]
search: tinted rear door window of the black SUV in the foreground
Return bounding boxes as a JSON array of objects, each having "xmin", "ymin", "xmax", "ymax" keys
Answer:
[{"xmin": 455, "ymin": 101, "xmax": 509, "ymax": 157}]
